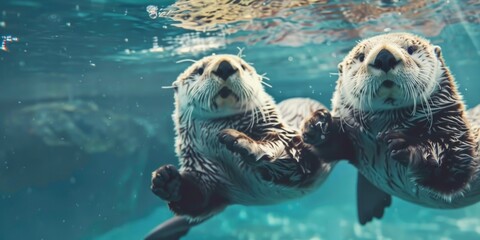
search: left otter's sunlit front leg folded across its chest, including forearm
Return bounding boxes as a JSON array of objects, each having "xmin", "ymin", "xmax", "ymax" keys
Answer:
[{"xmin": 218, "ymin": 129, "xmax": 286, "ymax": 163}]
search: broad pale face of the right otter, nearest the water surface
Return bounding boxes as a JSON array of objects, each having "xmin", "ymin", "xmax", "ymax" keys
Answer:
[{"xmin": 338, "ymin": 33, "xmax": 443, "ymax": 110}]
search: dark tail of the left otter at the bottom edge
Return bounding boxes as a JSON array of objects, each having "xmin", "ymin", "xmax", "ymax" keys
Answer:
[{"xmin": 145, "ymin": 216, "xmax": 208, "ymax": 240}]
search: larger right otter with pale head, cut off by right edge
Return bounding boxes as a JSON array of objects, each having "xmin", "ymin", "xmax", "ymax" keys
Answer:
[{"xmin": 309, "ymin": 33, "xmax": 480, "ymax": 224}]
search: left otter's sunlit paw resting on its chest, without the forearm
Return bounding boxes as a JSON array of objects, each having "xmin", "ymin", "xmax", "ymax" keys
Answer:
[{"xmin": 218, "ymin": 129, "xmax": 273, "ymax": 163}]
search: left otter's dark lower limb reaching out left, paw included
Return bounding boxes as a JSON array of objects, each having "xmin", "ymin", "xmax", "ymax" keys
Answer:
[{"xmin": 151, "ymin": 165, "xmax": 227, "ymax": 220}]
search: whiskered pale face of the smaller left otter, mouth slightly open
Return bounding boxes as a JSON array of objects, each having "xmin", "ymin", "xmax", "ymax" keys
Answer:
[{"xmin": 173, "ymin": 55, "xmax": 264, "ymax": 118}]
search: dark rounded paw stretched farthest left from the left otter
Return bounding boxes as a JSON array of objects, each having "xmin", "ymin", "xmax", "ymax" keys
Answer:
[{"xmin": 151, "ymin": 165, "xmax": 182, "ymax": 202}]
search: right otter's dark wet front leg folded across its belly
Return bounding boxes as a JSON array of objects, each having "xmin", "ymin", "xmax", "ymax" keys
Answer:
[{"xmin": 380, "ymin": 130, "xmax": 477, "ymax": 198}]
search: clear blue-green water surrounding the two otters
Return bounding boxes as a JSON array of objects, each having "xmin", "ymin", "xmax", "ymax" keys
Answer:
[{"xmin": 0, "ymin": 0, "xmax": 480, "ymax": 240}]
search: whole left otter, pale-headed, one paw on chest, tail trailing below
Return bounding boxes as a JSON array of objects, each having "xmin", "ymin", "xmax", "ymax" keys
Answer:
[{"xmin": 147, "ymin": 55, "xmax": 335, "ymax": 239}]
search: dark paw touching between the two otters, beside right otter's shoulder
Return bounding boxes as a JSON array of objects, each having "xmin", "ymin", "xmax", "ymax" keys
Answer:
[{"xmin": 302, "ymin": 109, "xmax": 333, "ymax": 145}]
